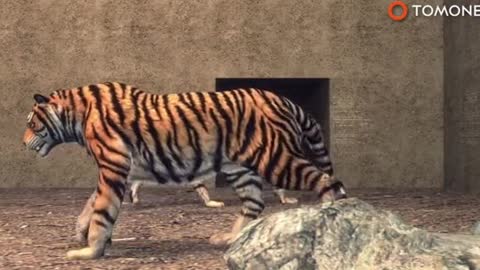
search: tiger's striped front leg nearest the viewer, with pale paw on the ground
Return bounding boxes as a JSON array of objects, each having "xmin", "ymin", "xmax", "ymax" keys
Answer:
[{"xmin": 67, "ymin": 143, "xmax": 130, "ymax": 259}]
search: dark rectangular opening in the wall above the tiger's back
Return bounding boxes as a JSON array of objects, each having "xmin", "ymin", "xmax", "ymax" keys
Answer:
[{"xmin": 215, "ymin": 78, "xmax": 330, "ymax": 147}]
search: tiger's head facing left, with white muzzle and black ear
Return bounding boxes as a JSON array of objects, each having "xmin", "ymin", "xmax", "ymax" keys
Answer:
[{"xmin": 23, "ymin": 94, "xmax": 64, "ymax": 157}]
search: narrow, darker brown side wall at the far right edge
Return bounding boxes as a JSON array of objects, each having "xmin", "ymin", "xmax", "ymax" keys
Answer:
[{"xmin": 444, "ymin": 0, "xmax": 480, "ymax": 192}]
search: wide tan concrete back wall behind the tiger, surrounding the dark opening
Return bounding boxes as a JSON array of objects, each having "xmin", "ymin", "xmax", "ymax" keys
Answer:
[{"xmin": 0, "ymin": 0, "xmax": 443, "ymax": 188}]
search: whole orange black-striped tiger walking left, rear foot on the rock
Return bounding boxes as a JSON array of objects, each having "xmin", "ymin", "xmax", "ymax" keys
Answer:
[{"xmin": 23, "ymin": 82, "xmax": 347, "ymax": 259}]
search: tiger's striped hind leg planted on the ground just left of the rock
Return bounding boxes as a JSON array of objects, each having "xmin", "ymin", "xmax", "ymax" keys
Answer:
[{"xmin": 209, "ymin": 167, "xmax": 265, "ymax": 245}]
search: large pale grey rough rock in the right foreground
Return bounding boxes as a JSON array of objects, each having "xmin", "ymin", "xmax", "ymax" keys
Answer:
[{"xmin": 225, "ymin": 198, "xmax": 480, "ymax": 270}]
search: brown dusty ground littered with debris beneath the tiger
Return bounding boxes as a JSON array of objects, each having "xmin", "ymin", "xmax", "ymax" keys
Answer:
[{"xmin": 0, "ymin": 188, "xmax": 480, "ymax": 269}]
